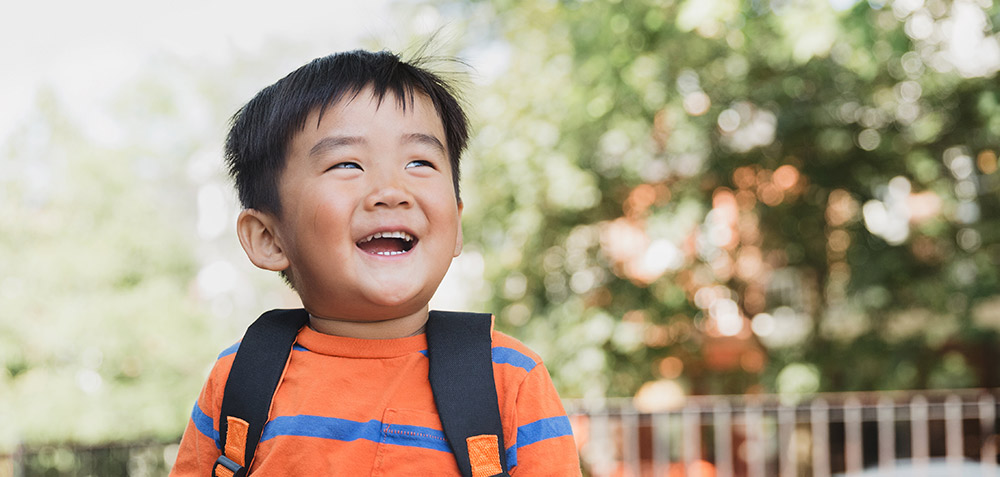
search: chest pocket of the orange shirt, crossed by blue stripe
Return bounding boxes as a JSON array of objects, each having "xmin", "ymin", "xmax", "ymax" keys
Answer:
[{"xmin": 372, "ymin": 409, "xmax": 461, "ymax": 477}]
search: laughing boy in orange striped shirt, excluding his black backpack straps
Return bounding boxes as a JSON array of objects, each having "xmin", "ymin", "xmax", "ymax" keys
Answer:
[{"xmin": 171, "ymin": 51, "xmax": 580, "ymax": 477}]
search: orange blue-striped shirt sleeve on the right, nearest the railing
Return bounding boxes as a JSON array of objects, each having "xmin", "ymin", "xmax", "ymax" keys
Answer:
[{"xmin": 507, "ymin": 364, "xmax": 581, "ymax": 477}]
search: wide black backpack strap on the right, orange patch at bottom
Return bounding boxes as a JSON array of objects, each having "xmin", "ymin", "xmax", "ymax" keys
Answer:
[{"xmin": 427, "ymin": 311, "xmax": 508, "ymax": 477}]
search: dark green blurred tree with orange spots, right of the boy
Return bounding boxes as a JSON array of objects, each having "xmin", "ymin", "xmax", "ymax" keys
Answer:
[{"xmin": 454, "ymin": 0, "xmax": 1000, "ymax": 396}]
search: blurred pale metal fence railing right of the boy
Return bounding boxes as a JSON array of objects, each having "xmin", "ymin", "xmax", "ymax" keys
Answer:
[{"xmin": 567, "ymin": 390, "xmax": 1000, "ymax": 477}]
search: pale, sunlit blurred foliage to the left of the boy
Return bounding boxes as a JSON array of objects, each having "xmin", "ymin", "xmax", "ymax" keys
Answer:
[{"xmin": 0, "ymin": 54, "xmax": 250, "ymax": 451}]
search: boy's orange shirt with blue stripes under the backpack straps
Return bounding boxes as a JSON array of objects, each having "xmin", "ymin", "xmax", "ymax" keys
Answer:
[{"xmin": 170, "ymin": 327, "xmax": 580, "ymax": 477}]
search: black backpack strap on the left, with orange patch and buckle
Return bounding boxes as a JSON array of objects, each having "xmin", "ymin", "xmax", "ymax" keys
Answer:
[{"xmin": 212, "ymin": 308, "xmax": 309, "ymax": 477}]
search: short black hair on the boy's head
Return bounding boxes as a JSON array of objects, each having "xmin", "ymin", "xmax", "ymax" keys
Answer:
[{"xmin": 225, "ymin": 50, "xmax": 469, "ymax": 216}]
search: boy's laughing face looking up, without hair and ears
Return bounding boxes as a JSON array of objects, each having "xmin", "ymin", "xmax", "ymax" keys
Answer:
[{"xmin": 276, "ymin": 89, "xmax": 462, "ymax": 321}]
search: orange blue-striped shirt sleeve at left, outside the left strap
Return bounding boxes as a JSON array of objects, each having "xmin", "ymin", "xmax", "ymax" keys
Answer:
[{"xmin": 170, "ymin": 359, "xmax": 226, "ymax": 477}]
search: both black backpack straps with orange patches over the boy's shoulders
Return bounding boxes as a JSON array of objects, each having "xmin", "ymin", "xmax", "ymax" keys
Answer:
[{"xmin": 212, "ymin": 308, "xmax": 508, "ymax": 477}]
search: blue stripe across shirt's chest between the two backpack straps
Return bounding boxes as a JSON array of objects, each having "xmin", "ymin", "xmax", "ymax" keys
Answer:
[{"xmin": 260, "ymin": 415, "xmax": 451, "ymax": 452}]
